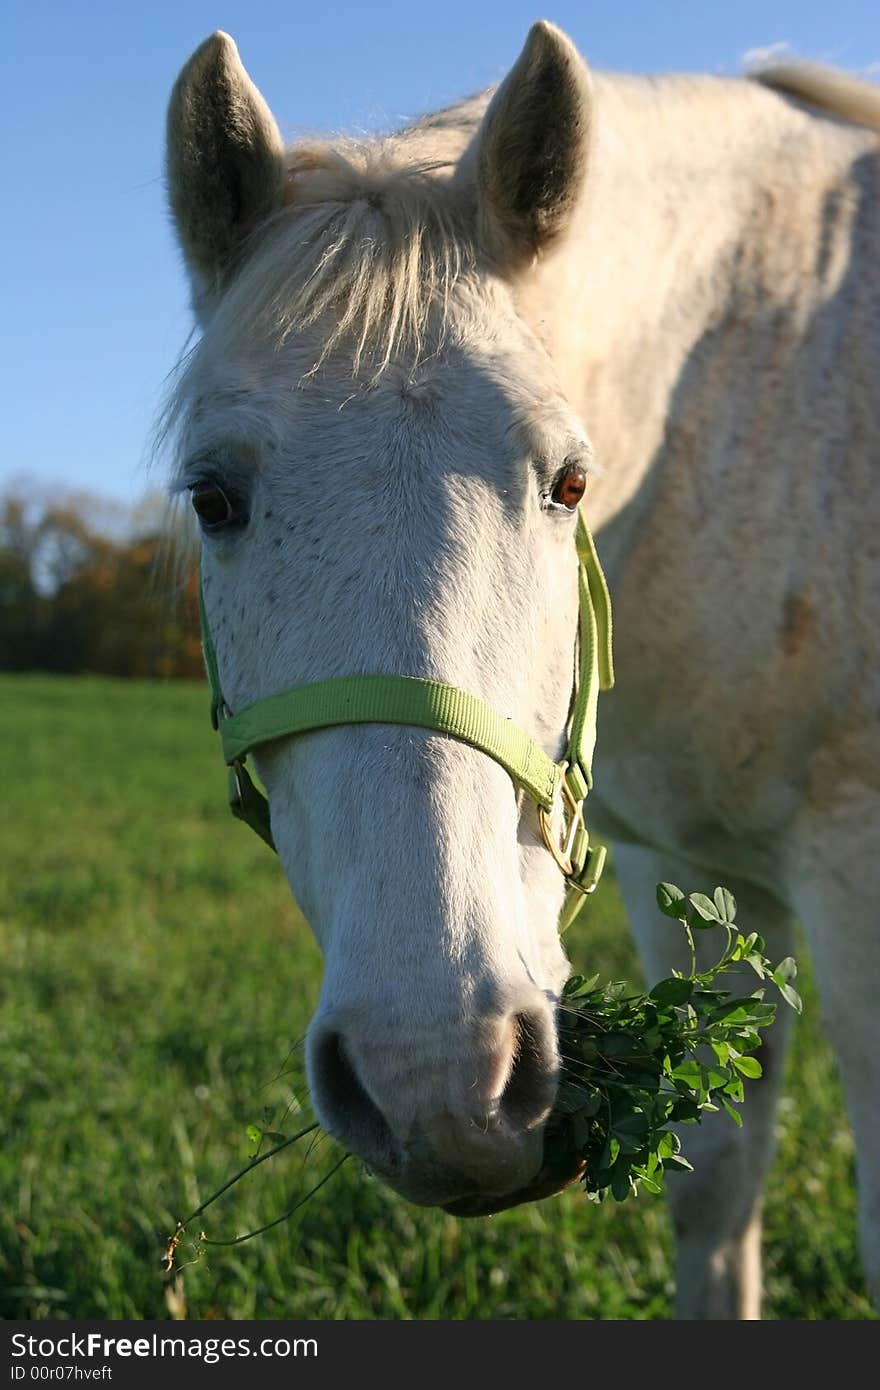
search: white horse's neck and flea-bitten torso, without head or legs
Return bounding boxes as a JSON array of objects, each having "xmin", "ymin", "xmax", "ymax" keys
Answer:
[{"xmin": 556, "ymin": 79, "xmax": 880, "ymax": 867}]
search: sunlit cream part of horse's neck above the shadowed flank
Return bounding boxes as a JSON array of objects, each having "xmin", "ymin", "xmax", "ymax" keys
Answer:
[{"xmin": 523, "ymin": 75, "xmax": 876, "ymax": 542}]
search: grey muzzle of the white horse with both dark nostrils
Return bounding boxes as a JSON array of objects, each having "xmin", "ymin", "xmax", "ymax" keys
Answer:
[{"xmin": 309, "ymin": 990, "xmax": 559, "ymax": 1215}]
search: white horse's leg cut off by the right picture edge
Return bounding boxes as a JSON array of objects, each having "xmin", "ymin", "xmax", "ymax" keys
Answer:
[{"xmin": 790, "ymin": 792, "xmax": 880, "ymax": 1304}]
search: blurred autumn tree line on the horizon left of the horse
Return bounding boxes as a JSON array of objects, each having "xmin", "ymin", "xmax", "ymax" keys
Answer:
[{"xmin": 0, "ymin": 487, "xmax": 204, "ymax": 680}]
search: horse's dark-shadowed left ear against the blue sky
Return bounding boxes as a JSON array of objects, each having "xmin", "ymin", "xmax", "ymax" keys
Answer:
[{"xmin": 167, "ymin": 31, "xmax": 285, "ymax": 315}]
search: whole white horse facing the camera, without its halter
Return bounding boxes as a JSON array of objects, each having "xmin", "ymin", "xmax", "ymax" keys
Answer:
[{"xmin": 161, "ymin": 24, "xmax": 880, "ymax": 1318}]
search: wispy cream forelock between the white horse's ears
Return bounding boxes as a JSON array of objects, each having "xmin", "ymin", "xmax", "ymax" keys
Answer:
[{"xmin": 198, "ymin": 132, "xmax": 477, "ymax": 373}]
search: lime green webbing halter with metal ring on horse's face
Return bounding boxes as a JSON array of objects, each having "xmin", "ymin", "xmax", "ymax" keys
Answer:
[{"xmin": 199, "ymin": 512, "xmax": 614, "ymax": 931}]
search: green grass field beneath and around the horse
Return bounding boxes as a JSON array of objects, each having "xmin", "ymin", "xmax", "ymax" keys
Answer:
[{"xmin": 0, "ymin": 677, "xmax": 872, "ymax": 1319}]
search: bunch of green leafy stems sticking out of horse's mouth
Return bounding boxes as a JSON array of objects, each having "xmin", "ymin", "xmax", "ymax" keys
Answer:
[{"xmin": 545, "ymin": 883, "xmax": 801, "ymax": 1201}]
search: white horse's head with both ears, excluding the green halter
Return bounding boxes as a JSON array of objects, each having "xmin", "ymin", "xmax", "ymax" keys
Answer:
[{"xmin": 168, "ymin": 24, "xmax": 592, "ymax": 1213}]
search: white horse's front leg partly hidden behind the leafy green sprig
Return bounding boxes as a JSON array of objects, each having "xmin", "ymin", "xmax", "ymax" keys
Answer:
[{"xmin": 614, "ymin": 845, "xmax": 792, "ymax": 1319}]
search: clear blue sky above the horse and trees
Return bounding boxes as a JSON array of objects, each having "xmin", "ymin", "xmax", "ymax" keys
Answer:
[{"xmin": 0, "ymin": 0, "xmax": 880, "ymax": 514}]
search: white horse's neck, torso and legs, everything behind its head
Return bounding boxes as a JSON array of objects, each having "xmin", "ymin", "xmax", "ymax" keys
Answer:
[{"xmin": 542, "ymin": 73, "xmax": 880, "ymax": 1316}]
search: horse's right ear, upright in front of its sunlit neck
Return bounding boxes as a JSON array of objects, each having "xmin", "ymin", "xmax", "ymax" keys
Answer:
[{"xmin": 466, "ymin": 19, "xmax": 592, "ymax": 265}]
